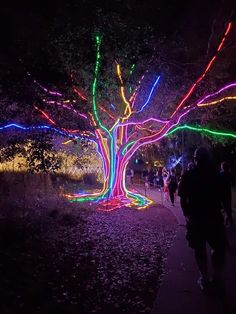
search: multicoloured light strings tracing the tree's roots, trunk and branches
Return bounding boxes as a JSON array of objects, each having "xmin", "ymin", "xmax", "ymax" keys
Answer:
[{"xmin": 0, "ymin": 23, "xmax": 236, "ymax": 211}]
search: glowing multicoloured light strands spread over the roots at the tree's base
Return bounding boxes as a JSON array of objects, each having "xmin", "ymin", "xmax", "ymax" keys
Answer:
[{"xmin": 65, "ymin": 190, "xmax": 153, "ymax": 211}]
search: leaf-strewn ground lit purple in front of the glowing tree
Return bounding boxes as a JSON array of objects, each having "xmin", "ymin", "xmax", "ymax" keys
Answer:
[{"xmin": 0, "ymin": 186, "xmax": 177, "ymax": 314}]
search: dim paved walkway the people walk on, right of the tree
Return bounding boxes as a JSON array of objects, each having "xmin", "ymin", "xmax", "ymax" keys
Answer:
[{"xmin": 135, "ymin": 186, "xmax": 236, "ymax": 314}]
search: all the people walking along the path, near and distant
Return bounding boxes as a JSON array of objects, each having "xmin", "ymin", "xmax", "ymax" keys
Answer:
[{"xmin": 128, "ymin": 147, "xmax": 233, "ymax": 291}]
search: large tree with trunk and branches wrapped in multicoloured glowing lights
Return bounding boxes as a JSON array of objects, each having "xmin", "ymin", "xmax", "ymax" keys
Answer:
[{"xmin": 0, "ymin": 23, "xmax": 236, "ymax": 209}]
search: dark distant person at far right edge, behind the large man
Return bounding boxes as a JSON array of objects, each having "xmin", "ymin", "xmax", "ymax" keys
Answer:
[{"xmin": 220, "ymin": 161, "xmax": 233, "ymax": 225}]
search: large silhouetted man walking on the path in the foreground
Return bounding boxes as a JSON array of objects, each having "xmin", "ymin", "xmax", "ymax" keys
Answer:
[{"xmin": 178, "ymin": 147, "xmax": 226, "ymax": 290}]
